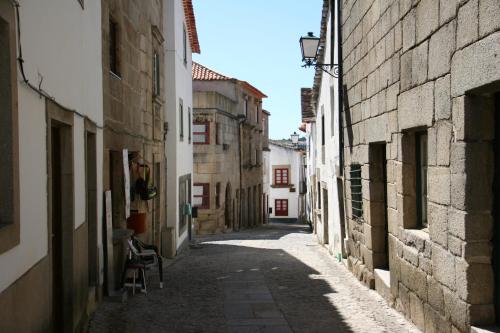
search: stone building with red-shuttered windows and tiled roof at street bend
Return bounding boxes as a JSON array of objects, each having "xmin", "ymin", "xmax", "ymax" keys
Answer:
[{"xmin": 193, "ymin": 63, "xmax": 267, "ymax": 233}]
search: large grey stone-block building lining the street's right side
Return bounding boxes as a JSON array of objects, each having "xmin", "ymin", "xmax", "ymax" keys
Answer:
[{"xmin": 339, "ymin": 0, "xmax": 500, "ymax": 332}]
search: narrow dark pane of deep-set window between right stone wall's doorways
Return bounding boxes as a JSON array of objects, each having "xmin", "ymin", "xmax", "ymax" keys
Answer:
[{"xmin": 415, "ymin": 132, "xmax": 428, "ymax": 229}]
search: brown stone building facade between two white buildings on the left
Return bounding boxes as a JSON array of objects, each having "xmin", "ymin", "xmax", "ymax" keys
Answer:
[{"xmin": 101, "ymin": 0, "xmax": 165, "ymax": 288}]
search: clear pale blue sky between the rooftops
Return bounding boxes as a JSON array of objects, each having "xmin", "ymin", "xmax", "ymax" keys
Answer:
[{"xmin": 193, "ymin": 0, "xmax": 323, "ymax": 139}]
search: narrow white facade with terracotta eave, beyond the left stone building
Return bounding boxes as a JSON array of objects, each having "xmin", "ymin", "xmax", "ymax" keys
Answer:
[{"xmin": 163, "ymin": 0, "xmax": 200, "ymax": 256}]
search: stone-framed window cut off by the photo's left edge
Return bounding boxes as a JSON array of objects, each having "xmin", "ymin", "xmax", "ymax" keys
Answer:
[{"xmin": 0, "ymin": 1, "xmax": 20, "ymax": 254}]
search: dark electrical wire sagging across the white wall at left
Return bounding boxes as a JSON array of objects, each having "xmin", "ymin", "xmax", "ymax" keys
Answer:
[{"xmin": 11, "ymin": 0, "xmax": 103, "ymax": 129}]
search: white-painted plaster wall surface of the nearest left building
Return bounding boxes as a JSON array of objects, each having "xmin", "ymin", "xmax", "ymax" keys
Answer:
[{"xmin": 0, "ymin": 0, "xmax": 102, "ymax": 292}]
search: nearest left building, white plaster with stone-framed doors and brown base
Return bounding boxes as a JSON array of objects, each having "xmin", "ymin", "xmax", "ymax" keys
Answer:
[{"xmin": 0, "ymin": 0, "xmax": 103, "ymax": 332}]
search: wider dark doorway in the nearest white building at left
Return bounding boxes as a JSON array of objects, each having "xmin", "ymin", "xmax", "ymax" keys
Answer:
[{"xmin": 48, "ymin": 119, "xmax": 74, "ymax": 332}]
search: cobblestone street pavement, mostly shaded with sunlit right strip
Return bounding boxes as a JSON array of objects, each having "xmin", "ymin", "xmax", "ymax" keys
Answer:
[{"xmin": 90, "ymin": 224, "xmax": 419, "ymax": 333}]
